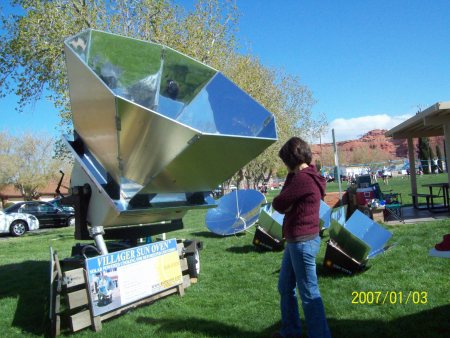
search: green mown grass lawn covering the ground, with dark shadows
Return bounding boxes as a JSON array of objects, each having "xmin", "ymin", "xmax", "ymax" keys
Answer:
[{"xmin": 0, "ymin": 177, "xmax": 450, "ymax": 338}]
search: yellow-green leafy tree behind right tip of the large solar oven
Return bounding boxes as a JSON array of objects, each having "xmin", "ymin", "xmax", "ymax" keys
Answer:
[{"xmin": 224, "ymin": 55, "xmax": 326, "ymax": 182}]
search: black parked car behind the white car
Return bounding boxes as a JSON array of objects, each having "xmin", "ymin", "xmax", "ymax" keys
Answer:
[{"xmin": 5, "ymin": 201, "xmax": 75, "ymax": 228}]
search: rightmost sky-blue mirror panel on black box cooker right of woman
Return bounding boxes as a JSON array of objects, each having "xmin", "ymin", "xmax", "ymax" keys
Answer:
[{"xmin": 344, "ymin": 210, "xmax": 392, "ymax": 258}]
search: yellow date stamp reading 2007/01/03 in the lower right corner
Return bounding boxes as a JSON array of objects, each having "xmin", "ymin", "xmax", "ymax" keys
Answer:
[{"xmin": 352, "ymin": 291, "xmax": 428, "ymax": 305}]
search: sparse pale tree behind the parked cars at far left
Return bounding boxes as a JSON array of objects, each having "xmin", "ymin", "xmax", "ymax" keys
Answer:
[{"xmin": 0, "ymin": 132, "xmax": 62, "ymax": 201}]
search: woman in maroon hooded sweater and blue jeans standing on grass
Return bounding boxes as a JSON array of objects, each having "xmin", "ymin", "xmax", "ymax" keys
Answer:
[{"xmin": 272, "ymin": 137, "xmax": 331, "ymax": 337}]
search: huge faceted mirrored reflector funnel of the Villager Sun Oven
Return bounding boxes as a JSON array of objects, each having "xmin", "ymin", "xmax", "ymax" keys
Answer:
[{"xmin": 65, "ymin": 30, "xmax": 277, "ymax": 198}]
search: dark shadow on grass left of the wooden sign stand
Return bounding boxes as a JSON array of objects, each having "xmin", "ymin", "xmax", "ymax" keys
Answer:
[{"xmin": 0, "ymin": 261, "xmax": 50, "ymax": 335}]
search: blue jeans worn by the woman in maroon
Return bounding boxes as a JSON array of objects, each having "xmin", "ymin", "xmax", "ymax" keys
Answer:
[{"xmin": 278, "ymin": 236, "xmax": 331, "ymax": 338}]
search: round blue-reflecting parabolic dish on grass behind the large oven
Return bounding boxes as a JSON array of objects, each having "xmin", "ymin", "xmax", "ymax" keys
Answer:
[{"xmin": 206, "ymin": 190, "xmax": 266, "ymax": 236}]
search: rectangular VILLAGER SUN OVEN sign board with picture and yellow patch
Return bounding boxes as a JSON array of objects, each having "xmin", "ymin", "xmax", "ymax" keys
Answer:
[{"xmin": 86, "ymin": 239, "xmax": 183, "ymax": 316}]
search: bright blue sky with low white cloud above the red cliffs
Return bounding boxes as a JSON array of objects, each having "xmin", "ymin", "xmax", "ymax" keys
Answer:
[{"xmin": 0, "ymin": 0, "xmax": 450, "ymax": 142}]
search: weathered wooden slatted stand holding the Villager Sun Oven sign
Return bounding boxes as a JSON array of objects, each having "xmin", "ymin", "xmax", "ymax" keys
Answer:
[{"xmin": 49, "ymin": 243, "xmax": 197, "ymax": 337}]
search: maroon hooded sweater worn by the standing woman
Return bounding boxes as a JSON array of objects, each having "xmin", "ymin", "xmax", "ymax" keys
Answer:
[{"xmin": 272, "ymin": 165, "xmax": 326, "ymax": 241}]
